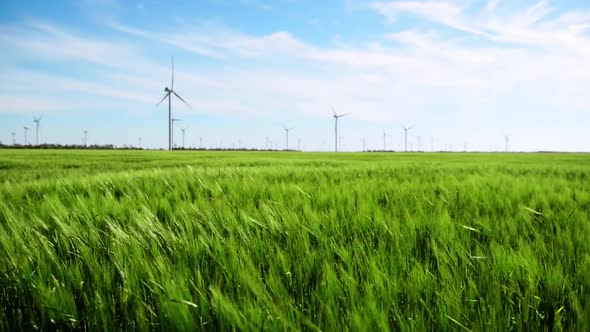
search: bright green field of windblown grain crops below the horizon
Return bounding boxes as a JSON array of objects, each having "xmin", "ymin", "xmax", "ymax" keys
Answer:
[{"xmin": 0, "ymin": 150, "xmax": 590, "ymax": 331}]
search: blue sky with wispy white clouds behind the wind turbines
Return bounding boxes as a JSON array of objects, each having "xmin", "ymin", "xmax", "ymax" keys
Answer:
[{"xmin": 0, "ymin": 0, "xmax": 590, "ymax": 151}]
